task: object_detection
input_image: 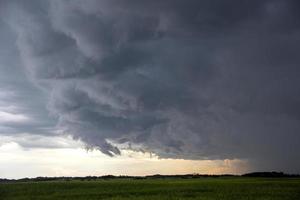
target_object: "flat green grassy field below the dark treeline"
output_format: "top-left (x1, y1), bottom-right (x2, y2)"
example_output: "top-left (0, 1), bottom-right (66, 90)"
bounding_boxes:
top-left (0, 177), bottom-right (300, 200)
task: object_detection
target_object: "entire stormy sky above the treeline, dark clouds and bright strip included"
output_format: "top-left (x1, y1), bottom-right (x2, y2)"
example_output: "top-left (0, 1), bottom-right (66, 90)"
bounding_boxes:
top-left (0, 0), bottom-right (300, 178)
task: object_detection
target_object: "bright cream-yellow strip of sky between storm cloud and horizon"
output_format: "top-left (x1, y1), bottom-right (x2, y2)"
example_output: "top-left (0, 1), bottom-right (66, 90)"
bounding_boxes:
top-left (0, 134), bottom-right (249, 178)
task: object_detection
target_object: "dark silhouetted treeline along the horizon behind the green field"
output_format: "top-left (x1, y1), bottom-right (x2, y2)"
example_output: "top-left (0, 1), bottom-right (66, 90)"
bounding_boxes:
top-left (0, 172), bottom-right (300, 183)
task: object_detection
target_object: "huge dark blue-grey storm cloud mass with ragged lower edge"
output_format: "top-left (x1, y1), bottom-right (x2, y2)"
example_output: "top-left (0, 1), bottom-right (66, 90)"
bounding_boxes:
top-left (1, 0), bottom-right (300, 172)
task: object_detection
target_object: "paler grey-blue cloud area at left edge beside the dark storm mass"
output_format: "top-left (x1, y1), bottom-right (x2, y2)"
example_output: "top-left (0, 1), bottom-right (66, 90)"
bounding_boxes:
top-left (0, 13), bottom-right (55, 135)
